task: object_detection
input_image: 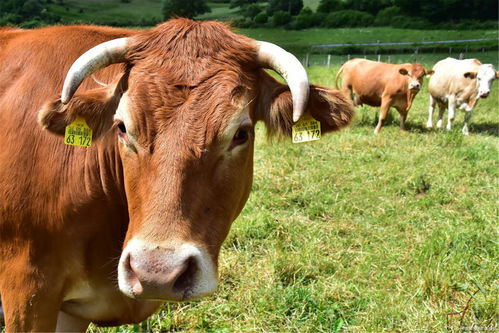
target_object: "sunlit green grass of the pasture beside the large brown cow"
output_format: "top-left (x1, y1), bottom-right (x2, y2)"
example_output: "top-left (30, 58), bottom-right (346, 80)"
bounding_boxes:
top-left (91, 67), bottom-right (499, 332)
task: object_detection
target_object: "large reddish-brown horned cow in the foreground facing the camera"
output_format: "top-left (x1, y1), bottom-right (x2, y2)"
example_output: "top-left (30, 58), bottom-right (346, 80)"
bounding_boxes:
top-left (0, 19), bottom-right (354, 332)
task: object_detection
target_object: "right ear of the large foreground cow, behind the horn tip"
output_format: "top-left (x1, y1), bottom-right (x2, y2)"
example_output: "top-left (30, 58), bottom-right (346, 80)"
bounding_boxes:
top-left (256, 75), bottom-right (355, 138)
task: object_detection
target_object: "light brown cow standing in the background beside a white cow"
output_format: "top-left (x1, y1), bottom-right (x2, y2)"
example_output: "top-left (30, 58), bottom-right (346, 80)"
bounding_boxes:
top-left (336, 59), bottom-right (432, 133)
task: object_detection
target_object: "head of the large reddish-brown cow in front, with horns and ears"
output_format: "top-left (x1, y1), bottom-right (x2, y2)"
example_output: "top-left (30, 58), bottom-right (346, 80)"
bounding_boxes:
top-left (39, 19), bottom-right (354, 301)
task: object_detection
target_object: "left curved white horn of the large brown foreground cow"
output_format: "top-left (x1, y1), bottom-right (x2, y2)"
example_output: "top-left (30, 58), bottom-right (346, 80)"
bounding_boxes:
top-left (61, 37), bottom-right (128, 104)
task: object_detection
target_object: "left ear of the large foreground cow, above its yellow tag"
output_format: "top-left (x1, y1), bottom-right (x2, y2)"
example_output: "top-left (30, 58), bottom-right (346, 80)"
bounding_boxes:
top-left (38, 78), bottom-right (123, 139)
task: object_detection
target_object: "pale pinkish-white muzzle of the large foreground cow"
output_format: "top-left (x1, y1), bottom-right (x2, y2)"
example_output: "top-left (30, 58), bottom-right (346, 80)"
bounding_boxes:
top-left (118, 239), bottom-right (218, 302)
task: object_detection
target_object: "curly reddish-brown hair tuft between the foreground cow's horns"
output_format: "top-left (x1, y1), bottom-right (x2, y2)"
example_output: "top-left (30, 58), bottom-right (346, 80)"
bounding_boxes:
top-left (128, 18), bottom-right (257, 76)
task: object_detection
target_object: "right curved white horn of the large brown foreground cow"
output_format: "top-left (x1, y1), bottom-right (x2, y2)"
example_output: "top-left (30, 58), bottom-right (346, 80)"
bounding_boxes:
top-left (257, 41), bottom-right (310, 122)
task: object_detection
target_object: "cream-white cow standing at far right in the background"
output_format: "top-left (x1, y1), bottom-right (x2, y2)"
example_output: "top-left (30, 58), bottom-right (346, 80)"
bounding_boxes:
top-left (426, 58), bottom-right (499, 135)
